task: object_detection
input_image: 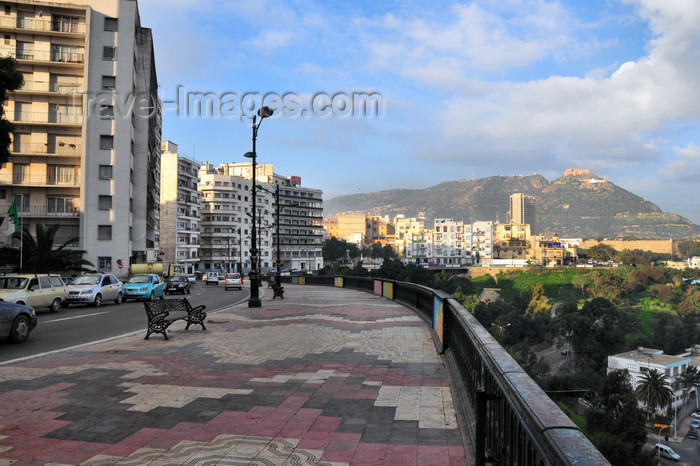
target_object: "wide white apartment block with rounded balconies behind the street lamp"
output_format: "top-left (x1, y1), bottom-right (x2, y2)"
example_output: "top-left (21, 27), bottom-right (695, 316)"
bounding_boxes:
top-left (199, 163), bottom-right (323, 273)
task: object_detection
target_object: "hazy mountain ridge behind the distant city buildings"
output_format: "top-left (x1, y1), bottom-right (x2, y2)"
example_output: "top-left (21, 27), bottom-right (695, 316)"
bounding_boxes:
top-left (323, 168), bottom-right (700, 239)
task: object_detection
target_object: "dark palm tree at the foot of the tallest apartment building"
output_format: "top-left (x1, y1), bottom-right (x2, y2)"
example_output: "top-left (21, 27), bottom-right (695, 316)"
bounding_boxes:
top-left (0, 223), bottom-right (93, 273)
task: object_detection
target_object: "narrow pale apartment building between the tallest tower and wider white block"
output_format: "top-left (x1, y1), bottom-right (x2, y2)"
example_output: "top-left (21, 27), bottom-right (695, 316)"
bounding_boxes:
top-left (160, 141), bottom-right (200, 273)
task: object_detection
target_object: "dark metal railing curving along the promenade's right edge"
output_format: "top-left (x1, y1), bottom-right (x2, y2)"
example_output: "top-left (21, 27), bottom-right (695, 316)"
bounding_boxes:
top-left (292, 276), bottom-right (610, 466)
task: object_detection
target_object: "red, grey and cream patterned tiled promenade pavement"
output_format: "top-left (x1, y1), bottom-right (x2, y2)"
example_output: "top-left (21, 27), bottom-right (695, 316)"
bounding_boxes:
top-left (0, 285), bottom-right (466, 465)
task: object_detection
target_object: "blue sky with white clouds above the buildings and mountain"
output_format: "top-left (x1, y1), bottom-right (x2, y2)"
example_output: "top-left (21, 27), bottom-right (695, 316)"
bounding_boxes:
top-left (139, 0), bottom-right (700, 223)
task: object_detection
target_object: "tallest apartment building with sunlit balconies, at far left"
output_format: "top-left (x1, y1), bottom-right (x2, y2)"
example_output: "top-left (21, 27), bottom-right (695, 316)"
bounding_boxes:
top-left (0, 0), bottom-right (162, 275)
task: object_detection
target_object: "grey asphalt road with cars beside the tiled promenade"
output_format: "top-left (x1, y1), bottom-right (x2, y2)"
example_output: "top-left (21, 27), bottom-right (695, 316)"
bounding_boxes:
top-left (0, 281), bottom-right (248, 364)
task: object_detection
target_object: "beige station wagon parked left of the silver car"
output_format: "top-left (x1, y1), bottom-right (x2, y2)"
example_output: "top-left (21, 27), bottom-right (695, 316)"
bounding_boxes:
top-left (0, 274), bottom-right (68, 312)
